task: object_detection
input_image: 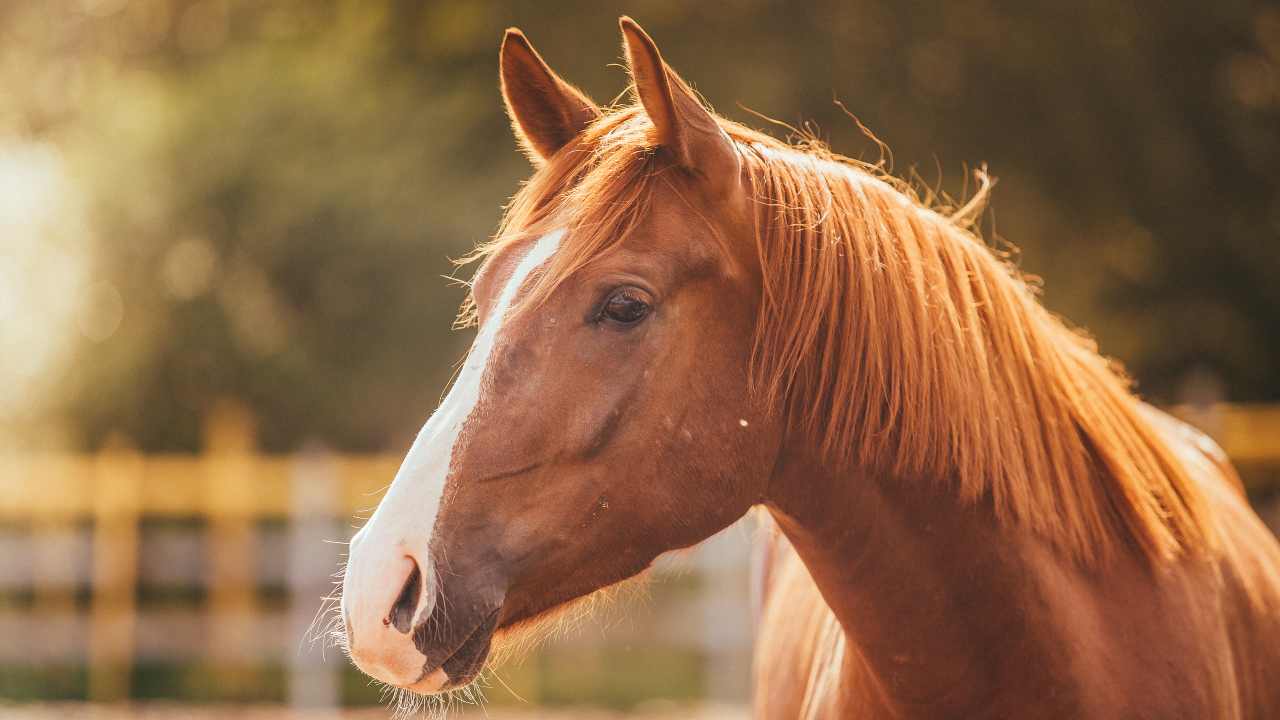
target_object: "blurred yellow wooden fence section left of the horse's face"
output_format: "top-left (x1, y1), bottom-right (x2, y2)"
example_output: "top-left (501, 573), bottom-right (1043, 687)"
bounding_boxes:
top-left (0, 405), bottom-right (399, 701)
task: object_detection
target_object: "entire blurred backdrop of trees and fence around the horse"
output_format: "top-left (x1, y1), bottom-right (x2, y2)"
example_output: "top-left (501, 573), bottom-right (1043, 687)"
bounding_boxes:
top-left (0, 0), bottom-right (1280, 717)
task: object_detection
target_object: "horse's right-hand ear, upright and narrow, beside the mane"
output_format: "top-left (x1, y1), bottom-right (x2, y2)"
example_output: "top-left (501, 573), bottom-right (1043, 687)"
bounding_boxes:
top-left (618, 15), bottom-right (737, 178)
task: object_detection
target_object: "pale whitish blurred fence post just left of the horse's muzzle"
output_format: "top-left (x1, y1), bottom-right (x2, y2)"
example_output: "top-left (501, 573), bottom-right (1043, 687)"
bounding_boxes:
top-left (288, 445), bottom-right (347, 716)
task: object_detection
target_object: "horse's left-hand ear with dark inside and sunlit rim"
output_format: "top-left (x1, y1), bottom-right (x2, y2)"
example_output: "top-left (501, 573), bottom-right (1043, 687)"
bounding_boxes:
top-left (498, 28), bottom-right (600, 165)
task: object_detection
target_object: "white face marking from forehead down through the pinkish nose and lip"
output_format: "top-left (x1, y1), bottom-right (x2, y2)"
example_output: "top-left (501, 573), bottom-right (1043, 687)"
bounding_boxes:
top-left (342, 229), bottom-right (564, 692)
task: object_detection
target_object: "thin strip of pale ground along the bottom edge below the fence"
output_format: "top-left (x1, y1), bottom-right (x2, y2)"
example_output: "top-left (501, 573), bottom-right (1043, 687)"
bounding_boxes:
top-left (0, 703), bottom-right (748, 720)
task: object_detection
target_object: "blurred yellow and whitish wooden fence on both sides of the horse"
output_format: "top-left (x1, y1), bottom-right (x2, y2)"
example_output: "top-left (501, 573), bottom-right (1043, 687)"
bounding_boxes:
top-left (0, 405), bottom-right (1280, 705)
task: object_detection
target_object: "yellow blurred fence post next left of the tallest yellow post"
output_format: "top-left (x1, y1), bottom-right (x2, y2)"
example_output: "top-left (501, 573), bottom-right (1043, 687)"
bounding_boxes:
top-left (88, 430), bottom-right (143, 702)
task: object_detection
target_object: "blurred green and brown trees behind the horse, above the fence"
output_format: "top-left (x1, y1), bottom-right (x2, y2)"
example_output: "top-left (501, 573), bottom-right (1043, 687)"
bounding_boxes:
top-left (0, 0), bottom-right (1280, 450)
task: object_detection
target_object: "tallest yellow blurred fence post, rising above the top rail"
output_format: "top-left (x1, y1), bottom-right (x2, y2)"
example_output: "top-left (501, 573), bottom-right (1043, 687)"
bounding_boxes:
top-left (205, 400), bottom-right (257, 681)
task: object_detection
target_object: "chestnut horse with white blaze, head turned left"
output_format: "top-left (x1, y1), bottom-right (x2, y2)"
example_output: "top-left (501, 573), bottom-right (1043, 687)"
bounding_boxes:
top-left (340, 18), bottom-right (1280, 719)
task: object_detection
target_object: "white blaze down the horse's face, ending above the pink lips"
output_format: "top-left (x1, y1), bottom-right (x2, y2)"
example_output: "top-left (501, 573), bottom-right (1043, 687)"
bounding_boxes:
top-left (342, 229), bottom-right (564, 635)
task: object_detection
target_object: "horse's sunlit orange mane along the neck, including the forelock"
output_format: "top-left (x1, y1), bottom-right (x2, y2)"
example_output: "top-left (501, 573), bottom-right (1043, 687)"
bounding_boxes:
top-left (461, 106), bottom-right (1210, 564)
